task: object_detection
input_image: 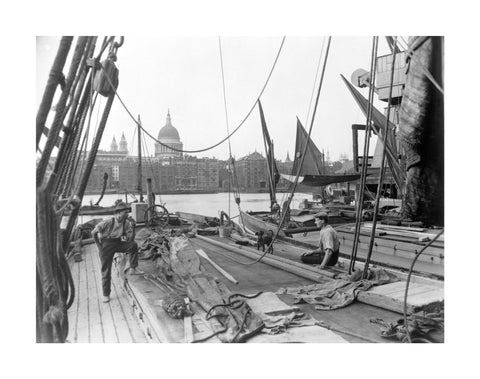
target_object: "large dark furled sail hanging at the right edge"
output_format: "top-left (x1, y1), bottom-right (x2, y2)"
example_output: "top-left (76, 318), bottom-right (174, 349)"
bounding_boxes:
top-left (398, 37), bottom-right (445, 225)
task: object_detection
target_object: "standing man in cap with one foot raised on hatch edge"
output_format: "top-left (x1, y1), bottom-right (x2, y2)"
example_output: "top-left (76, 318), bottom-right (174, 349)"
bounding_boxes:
top-left (92, 202), bottom-right (143, 303)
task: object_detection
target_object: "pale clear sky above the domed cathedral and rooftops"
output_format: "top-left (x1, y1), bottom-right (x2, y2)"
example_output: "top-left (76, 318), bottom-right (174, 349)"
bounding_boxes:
top-left (36, 35), bottom-right (398, 165)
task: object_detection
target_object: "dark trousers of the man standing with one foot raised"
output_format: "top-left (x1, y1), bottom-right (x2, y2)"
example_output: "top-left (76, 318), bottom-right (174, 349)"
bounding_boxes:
top-left (100, 238), bottom-right (138, 296)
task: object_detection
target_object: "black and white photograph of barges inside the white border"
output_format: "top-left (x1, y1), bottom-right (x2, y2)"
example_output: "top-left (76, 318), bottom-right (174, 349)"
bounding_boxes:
top-left (36, 36), bottom-right (445, 343)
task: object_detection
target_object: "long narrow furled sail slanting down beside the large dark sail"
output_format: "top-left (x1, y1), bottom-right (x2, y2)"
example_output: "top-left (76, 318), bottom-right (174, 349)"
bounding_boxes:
top-left (340, 75), bottom-right (405, 190)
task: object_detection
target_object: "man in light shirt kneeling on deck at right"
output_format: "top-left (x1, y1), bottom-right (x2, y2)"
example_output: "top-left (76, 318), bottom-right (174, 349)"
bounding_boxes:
top-left (301, 212), bottom-right (340, 268)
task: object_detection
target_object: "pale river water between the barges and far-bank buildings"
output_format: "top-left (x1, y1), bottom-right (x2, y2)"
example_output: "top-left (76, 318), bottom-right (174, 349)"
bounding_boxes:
top-left (79, 192), bottom-right (312, 223)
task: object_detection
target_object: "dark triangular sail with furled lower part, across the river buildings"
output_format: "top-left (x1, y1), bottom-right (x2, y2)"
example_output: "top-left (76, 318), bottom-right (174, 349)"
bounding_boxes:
top-left (281, 118), bottom-right (360, 187)
